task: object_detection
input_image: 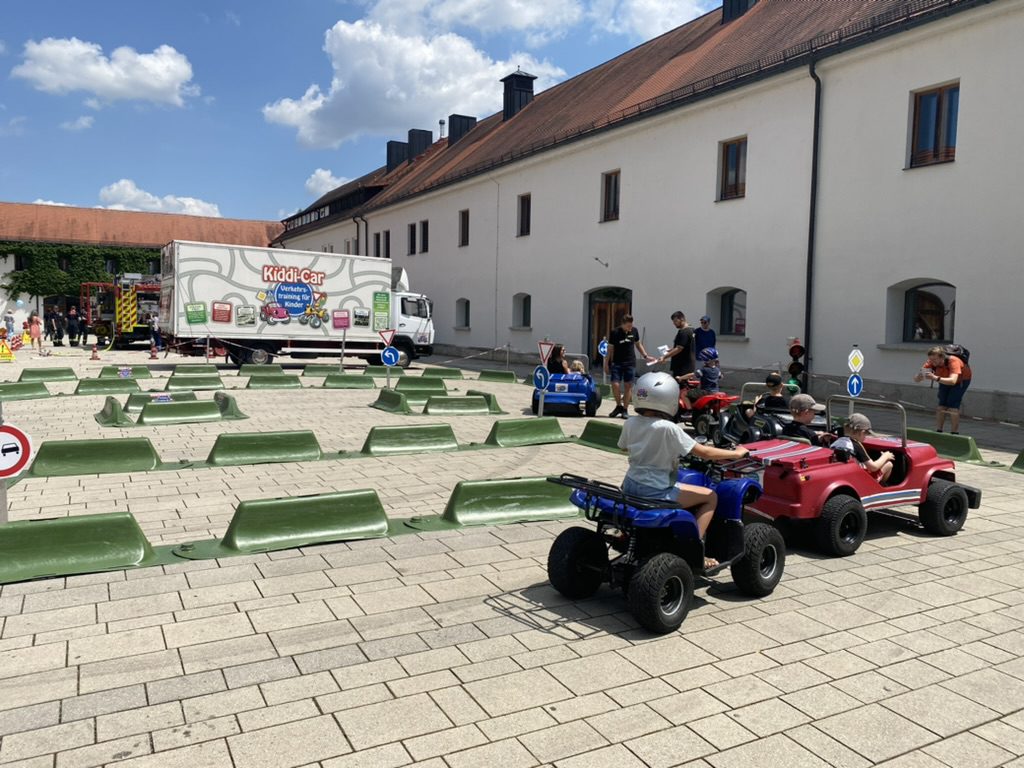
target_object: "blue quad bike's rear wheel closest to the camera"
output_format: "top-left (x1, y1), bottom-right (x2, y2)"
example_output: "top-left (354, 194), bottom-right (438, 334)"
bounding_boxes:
top-left (627, 552), bottom-right (693, 634)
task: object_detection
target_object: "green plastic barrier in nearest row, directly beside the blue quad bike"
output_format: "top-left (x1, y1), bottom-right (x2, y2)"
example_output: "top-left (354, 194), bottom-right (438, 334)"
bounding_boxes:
top-left (406, 477), bottom-right (580, 530)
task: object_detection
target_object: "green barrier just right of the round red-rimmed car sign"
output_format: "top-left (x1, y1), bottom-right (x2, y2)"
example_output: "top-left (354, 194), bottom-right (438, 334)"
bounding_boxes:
top-left (28, 438), bottom-right (160, 477)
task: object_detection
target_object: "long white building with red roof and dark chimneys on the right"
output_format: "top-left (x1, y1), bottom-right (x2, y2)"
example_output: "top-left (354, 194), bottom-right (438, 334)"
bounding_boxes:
top-left (279, 0), bottom-right (1024, 421)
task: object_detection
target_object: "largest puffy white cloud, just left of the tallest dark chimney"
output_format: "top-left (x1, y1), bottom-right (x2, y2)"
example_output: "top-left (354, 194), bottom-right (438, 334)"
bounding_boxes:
top-left (263, 20), bottom-right (565, 147)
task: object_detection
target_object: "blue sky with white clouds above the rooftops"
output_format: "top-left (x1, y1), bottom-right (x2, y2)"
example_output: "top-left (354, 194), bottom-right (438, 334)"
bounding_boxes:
top-left (0, 0), bottom-right (721, 219)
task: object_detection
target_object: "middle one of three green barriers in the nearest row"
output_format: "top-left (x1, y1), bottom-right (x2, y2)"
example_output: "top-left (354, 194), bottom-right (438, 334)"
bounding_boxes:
top-left (174, 483), bottom-right (387, 560)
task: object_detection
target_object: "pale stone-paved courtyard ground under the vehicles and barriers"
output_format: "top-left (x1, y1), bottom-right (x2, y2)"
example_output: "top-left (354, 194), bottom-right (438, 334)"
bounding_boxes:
top-left (0, 352), bottom-right (1024, 768)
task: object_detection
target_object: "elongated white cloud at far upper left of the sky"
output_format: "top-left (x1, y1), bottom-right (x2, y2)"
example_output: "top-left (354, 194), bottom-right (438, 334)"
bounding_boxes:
top-left (11, 37), bottom-right (199, 106)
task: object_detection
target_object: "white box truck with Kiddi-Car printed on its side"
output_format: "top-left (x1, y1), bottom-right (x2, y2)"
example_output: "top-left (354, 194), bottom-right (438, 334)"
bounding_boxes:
top-left (159, 241), bottom-right (434, 366)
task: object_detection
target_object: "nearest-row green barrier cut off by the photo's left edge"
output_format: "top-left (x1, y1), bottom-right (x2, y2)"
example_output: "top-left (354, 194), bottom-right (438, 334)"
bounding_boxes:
top-left (0, 512), bottom-right (162, 584)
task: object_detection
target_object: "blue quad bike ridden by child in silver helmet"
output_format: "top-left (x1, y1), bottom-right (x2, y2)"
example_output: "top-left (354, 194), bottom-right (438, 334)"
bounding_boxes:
top-left (548, 459), bottom-right (785, 634)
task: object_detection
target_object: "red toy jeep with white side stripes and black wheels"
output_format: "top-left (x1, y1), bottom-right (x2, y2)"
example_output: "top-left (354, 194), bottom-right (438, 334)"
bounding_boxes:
top-left (746, 396), bottom-right (981, 556)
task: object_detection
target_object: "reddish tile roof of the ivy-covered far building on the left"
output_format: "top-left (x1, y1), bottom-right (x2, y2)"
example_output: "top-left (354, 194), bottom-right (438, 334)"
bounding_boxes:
top-left (0, 203), bottom-right (284, 248)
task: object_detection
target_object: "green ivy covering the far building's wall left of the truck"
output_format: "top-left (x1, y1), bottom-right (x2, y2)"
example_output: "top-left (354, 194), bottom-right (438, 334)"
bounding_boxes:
top-left (0, 243), bottom-right (160, 298)
